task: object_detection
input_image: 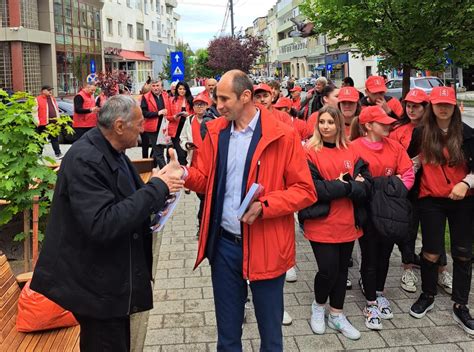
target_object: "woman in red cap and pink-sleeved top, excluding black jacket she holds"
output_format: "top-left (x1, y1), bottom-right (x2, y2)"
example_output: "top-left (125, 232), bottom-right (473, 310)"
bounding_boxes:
top-left (351, 106), bottom-right (415, 330)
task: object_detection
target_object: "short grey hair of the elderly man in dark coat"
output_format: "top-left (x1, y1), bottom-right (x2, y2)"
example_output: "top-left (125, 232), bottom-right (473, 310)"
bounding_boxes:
top-left (97, 95), bottom-right (138, 129)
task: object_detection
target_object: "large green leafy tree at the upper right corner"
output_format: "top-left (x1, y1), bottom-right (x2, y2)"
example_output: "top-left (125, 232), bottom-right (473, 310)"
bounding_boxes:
top-left (301, 0), bottom-right (474, 97)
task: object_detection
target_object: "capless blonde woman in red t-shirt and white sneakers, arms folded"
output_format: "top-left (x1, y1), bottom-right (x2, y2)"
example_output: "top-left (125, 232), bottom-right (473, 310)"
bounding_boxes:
top-left (304, 106), bottom-right (364, 340)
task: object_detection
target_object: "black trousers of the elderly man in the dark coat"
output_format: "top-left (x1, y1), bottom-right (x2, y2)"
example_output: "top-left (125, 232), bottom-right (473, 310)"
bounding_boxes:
top-left (74, 314), bottom-right (130, 352)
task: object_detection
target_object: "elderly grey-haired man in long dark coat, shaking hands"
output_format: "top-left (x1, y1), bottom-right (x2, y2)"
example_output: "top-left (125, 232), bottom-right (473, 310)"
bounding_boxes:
top-left (31, 95), bottom-right (183, 351)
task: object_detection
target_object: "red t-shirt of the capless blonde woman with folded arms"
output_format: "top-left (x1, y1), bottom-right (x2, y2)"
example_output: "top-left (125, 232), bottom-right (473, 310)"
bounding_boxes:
top-left (304, 145), bottom-right (362, 243)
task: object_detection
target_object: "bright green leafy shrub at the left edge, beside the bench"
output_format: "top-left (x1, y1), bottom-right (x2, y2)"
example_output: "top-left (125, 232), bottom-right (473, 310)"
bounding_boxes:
top-left (0, 90), bottom-right (73, 225)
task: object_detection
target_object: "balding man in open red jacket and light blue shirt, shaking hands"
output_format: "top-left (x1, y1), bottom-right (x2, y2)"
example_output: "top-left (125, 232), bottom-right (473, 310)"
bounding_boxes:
top-left (170, 70), bottom-right (316, 351)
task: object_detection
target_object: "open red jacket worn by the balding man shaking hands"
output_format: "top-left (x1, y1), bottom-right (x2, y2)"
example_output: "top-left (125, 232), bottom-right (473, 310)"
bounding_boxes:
top-left (185, 106), bottom-right (316, 281)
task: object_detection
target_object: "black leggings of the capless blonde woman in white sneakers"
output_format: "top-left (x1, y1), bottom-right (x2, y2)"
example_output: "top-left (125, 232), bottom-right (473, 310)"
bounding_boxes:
top-left (310, 241), bottom-right (354, 309)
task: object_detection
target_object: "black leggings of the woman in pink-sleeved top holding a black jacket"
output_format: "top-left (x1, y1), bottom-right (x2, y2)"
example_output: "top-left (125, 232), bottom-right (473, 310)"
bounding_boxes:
top-left (359, 221), bottom-right (394, 302)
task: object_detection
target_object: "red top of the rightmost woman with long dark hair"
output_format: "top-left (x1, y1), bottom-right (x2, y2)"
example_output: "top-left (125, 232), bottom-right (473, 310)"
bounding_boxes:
top-left (418, 148), bottom-right (469, 198)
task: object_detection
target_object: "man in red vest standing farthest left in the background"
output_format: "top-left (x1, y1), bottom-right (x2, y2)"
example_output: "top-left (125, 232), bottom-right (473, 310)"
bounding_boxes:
top-left (33, 85), bottom-right (63, 159)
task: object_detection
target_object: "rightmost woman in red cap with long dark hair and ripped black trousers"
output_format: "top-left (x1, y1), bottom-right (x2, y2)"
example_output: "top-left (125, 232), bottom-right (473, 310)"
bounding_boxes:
top-left (408, 87), bottom-right (474, 335)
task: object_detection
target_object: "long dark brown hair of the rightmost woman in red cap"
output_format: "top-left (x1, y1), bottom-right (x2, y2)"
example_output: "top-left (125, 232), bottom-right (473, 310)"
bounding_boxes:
top-left (421, 104), bottom-right (465, 166)
